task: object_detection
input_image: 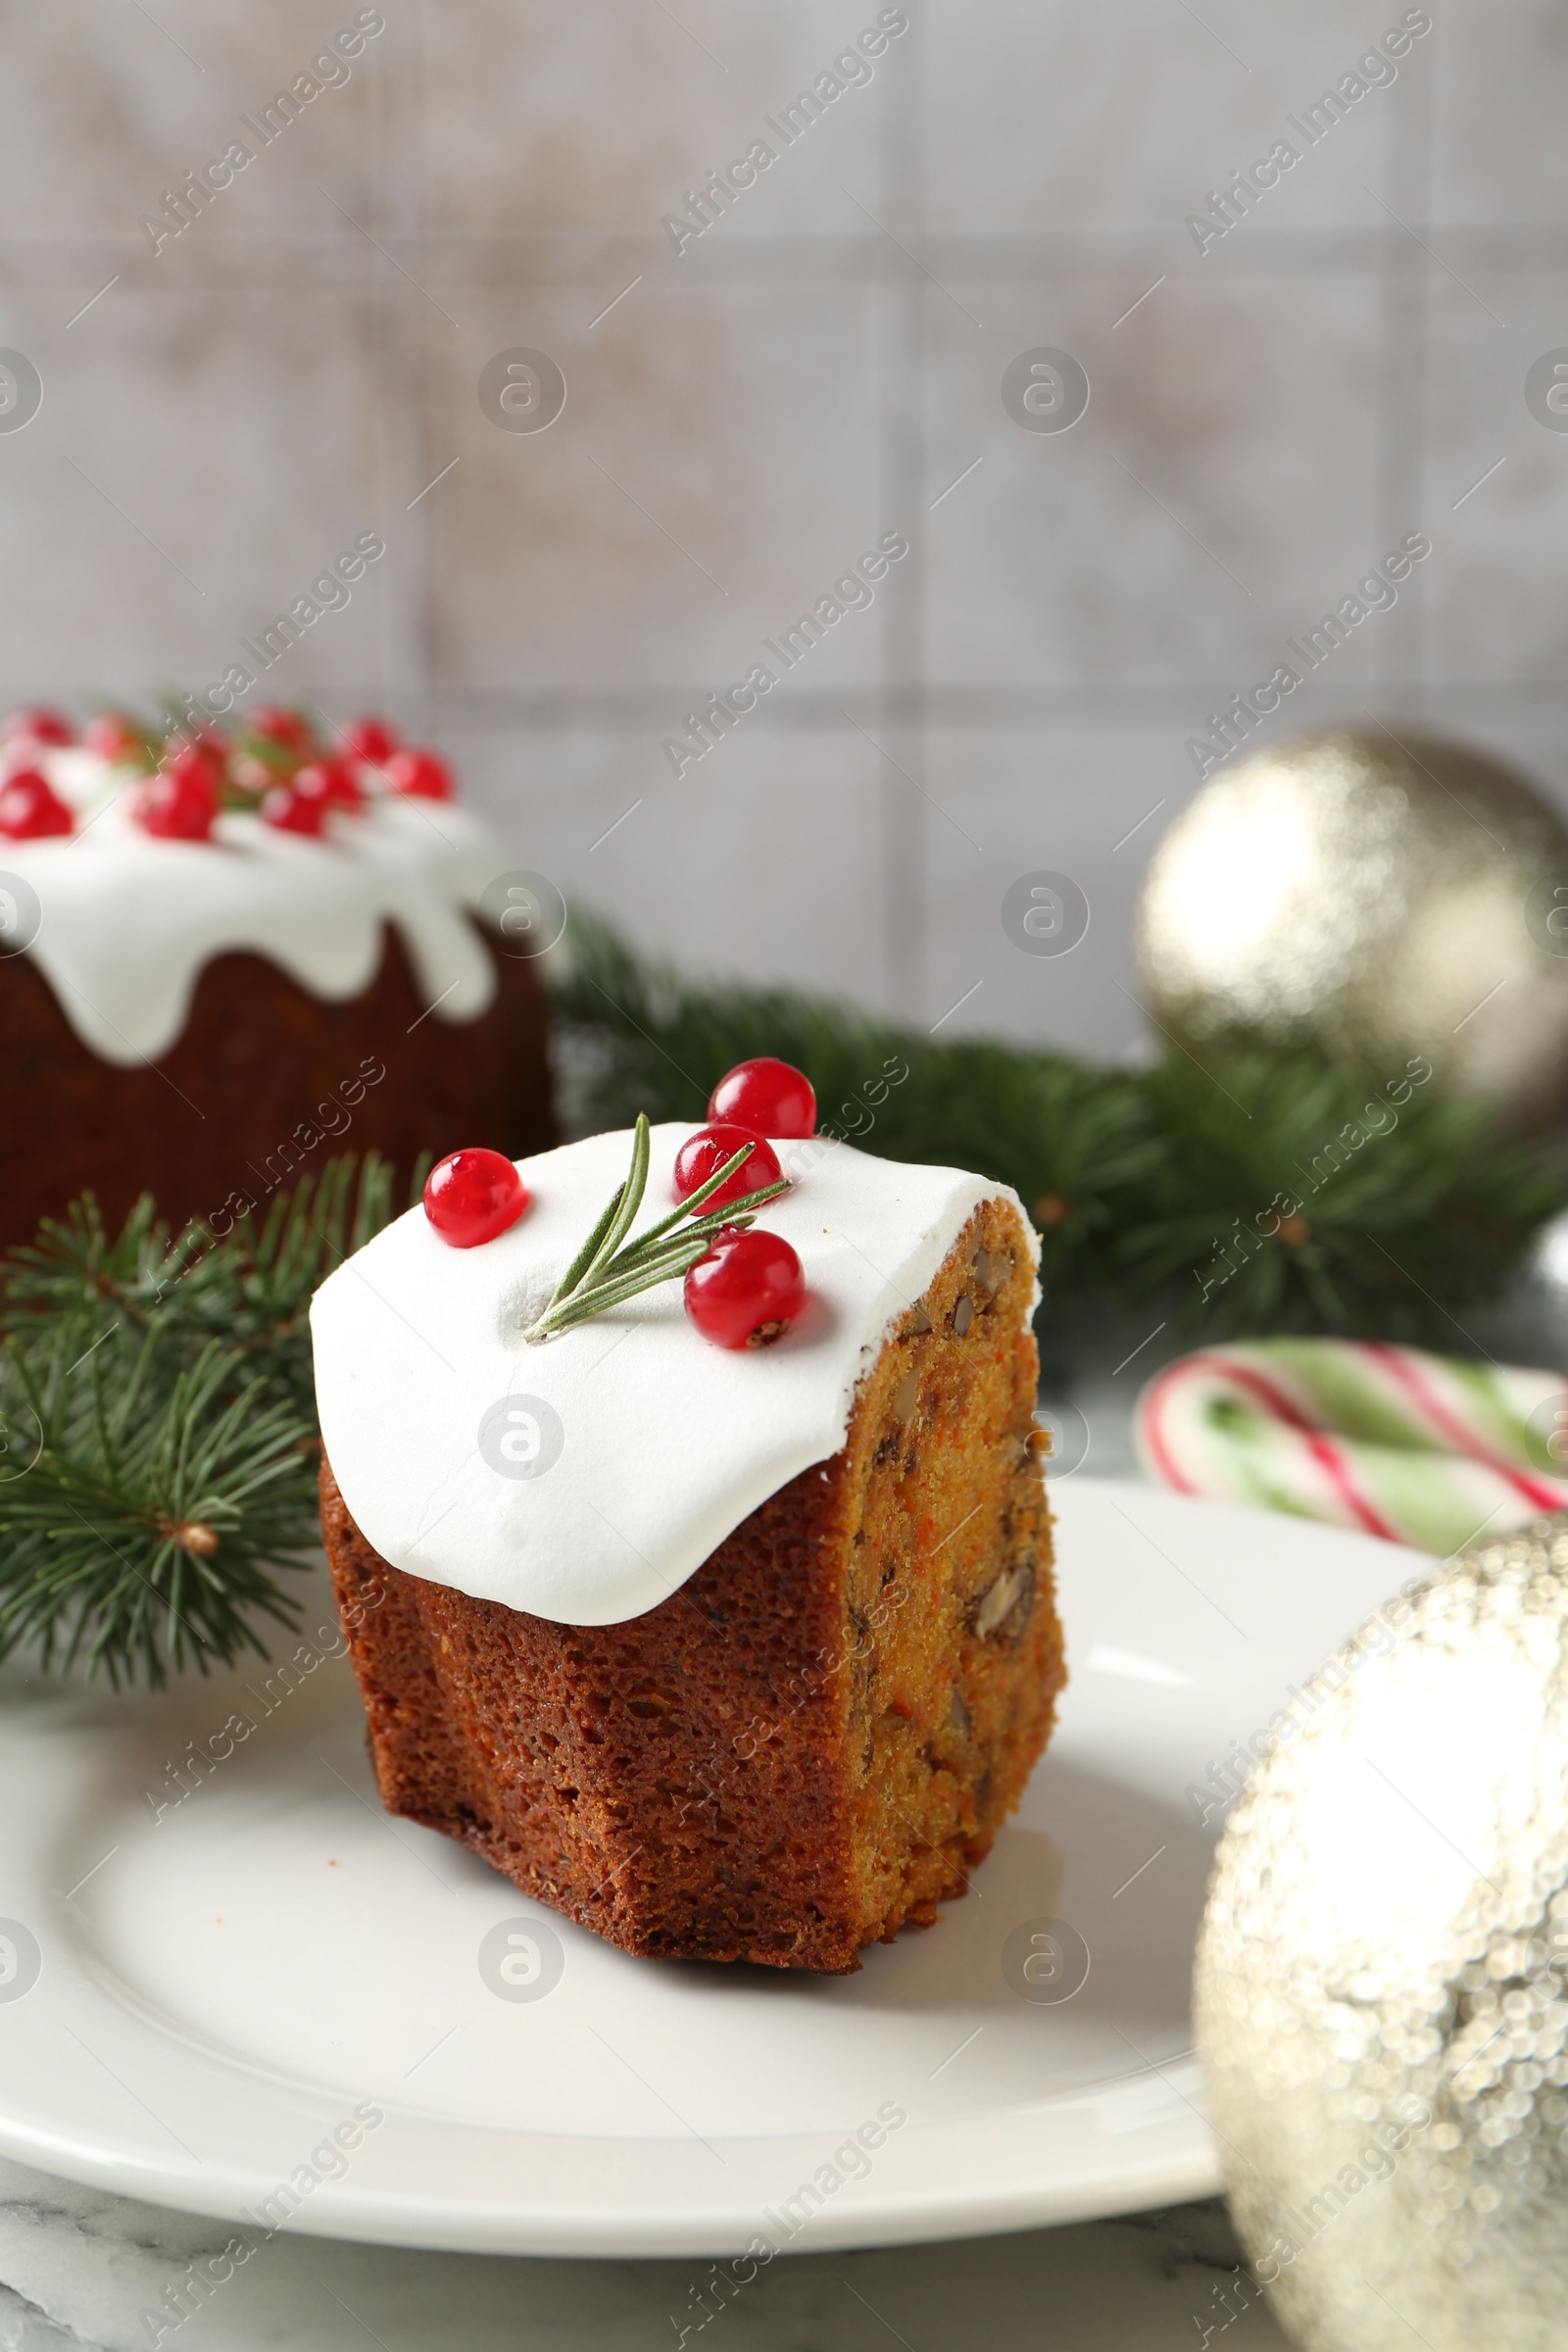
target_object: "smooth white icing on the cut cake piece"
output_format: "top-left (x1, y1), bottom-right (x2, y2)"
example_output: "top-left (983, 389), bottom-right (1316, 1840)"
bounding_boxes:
top-left (311, 1124), bottom-right (1022, 1625)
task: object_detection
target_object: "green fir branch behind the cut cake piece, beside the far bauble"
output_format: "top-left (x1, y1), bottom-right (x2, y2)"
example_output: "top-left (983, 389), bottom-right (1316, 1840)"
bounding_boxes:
top-left (555, 915), bottom-right (1568, 1350)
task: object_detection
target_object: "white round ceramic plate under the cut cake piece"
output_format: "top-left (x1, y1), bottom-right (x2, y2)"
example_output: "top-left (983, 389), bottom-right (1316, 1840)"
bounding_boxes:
top-left (0, 1477), bottom-right (1425, 2256)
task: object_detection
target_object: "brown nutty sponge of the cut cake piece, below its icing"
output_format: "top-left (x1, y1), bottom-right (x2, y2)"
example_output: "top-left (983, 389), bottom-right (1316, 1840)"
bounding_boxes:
top-left (322, 1200), bottom-right (1065, 1971)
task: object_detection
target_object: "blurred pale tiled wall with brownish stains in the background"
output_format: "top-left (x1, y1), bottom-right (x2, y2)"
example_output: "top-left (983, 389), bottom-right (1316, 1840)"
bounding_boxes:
top-left (0, 0), bottom-right (1568, 1054)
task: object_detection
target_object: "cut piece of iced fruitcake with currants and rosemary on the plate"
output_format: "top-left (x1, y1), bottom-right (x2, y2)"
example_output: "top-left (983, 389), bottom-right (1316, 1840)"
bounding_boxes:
top-left (313, 1063), bottom-right (1065, 1971)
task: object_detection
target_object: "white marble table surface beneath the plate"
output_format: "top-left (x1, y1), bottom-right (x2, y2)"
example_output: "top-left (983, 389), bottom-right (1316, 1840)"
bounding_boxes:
top-left (0, 1329), bottom-right (1286, 2352)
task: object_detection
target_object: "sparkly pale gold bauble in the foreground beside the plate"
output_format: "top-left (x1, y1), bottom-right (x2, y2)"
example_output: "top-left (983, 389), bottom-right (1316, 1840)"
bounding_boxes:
top-left (1195, 1512), bottom-right (1568, 2352)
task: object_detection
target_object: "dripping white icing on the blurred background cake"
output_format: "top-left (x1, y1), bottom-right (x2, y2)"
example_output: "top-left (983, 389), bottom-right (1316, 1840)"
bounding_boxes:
top-left (0, 751), bottom-right (506, 1068)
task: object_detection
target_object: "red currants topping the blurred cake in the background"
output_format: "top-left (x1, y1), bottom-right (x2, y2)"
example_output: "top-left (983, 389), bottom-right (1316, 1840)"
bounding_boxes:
top-left (0, 704), bottom-right (452, 842)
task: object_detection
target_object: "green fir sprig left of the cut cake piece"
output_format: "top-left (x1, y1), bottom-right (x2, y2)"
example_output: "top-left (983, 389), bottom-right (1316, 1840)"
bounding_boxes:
top-left (0, 1154), bottom-right (423, 1687)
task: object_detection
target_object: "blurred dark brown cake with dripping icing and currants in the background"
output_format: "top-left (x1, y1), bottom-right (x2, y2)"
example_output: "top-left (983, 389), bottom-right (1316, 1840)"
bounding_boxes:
top-left (0, 710), bottom-right (553, 1247)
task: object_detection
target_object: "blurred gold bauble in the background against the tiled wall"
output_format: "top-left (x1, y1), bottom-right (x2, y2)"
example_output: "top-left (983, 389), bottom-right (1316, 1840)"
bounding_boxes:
top-left (1138, 729), bottom-right (1568, 1124)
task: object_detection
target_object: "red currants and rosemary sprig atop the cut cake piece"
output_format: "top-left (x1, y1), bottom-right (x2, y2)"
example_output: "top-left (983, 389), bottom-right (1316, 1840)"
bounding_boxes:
top-left (425, 1058), bottom-right (815, 1348)
